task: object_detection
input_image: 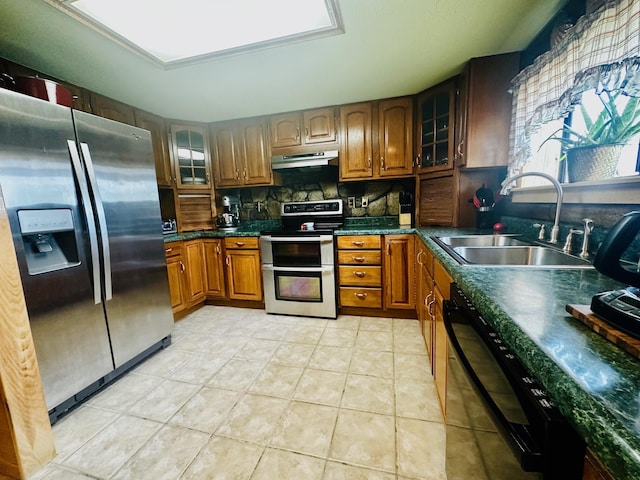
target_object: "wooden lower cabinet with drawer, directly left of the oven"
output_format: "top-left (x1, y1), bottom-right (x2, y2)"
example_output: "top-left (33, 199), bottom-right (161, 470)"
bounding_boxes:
top-left (224, 237), bottom-right (263, 302)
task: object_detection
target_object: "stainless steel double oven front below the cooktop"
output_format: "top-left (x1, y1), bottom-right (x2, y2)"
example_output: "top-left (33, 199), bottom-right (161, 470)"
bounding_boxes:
top-left (260, 233), bottom-right (337, 318)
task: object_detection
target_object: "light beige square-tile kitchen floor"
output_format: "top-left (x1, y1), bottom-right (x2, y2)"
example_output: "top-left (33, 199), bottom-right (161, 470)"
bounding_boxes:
top-left (33, 306), bottom-right (446, 480)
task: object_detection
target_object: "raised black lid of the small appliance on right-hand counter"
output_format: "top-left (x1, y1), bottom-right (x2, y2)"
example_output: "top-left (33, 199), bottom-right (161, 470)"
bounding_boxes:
top-left (593, 211), bottom-right (640, 287)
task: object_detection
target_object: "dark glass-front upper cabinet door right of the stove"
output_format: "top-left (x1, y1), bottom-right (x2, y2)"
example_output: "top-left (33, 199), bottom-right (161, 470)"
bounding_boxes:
top-left (417, 81), bottom-right (456, 173)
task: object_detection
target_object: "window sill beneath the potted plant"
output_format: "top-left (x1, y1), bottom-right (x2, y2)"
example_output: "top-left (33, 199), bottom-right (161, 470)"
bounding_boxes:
top-left (511, 175), bottom-right (640, 205)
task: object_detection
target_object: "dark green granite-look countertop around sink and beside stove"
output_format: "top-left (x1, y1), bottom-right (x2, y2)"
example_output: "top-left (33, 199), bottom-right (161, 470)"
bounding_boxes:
top-left (165, 221), bottom-right (640, 479)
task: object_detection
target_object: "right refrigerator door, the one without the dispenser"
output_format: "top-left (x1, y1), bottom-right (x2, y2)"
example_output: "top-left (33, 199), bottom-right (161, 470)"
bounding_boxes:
top-left (73, 111), bottom-right (173, 368)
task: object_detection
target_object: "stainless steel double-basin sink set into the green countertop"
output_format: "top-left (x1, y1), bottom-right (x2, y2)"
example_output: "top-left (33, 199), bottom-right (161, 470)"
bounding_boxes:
top-left (431, 235), bottom-right (593, 268)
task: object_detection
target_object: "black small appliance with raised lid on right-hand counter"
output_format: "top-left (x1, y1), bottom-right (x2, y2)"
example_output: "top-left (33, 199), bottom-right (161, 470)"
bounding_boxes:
top-left (591, 211), bottom-right (640, 339)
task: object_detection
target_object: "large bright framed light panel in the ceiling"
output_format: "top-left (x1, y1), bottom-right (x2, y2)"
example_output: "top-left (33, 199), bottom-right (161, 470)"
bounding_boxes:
top-left (44, 0), bottom-right (344, 67)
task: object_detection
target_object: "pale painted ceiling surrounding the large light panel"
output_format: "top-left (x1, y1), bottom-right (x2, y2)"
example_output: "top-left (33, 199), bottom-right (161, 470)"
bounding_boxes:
top-left (0, 0), bottom-right (565, 122)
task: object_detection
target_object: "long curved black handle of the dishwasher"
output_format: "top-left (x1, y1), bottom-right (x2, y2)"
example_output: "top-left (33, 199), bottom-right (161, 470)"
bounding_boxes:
top-left (442, 300), bottom-right (542, 471)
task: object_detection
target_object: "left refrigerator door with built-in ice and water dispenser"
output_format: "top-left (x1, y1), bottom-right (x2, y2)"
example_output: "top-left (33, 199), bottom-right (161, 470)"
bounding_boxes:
top-left (0, 90), bottom-right (114, 409)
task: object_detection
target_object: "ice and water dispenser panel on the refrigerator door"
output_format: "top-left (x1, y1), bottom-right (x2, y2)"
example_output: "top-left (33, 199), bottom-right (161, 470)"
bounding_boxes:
top-left (18, 208), bottom-right (80, 275)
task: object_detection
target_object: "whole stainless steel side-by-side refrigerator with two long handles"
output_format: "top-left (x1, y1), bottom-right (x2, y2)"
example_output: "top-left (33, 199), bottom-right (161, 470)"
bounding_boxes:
top-left (0, 90), bottom-right (173, 422)
